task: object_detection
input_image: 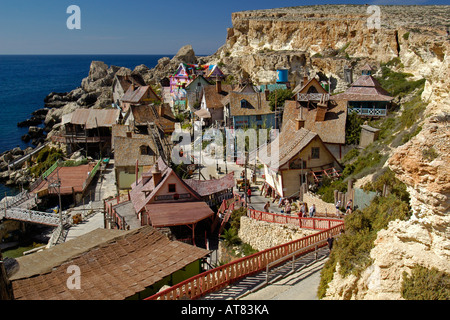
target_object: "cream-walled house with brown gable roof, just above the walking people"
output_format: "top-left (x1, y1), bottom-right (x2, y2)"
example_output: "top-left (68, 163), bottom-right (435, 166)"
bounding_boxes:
top-left (258, 119), bottom-right (342, 197)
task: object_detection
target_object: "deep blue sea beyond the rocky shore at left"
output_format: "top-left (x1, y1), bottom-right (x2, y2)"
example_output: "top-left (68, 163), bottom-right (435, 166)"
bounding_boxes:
top-left (0, 54), bottom-right (173, 199)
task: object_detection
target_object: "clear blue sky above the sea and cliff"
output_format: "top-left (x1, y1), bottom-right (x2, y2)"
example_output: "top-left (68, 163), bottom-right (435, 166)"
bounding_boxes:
top-left (0, 0), bottom-right (448, 55)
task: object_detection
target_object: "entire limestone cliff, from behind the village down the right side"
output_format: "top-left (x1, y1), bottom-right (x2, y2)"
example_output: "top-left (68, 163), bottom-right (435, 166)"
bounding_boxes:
top-left (201, 5), bottom-right (450, 299)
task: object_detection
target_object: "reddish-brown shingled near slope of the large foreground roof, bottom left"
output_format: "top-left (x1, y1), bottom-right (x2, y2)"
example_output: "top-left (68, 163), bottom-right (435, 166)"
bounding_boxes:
top-left (12, 226), bottom-right (209, 300)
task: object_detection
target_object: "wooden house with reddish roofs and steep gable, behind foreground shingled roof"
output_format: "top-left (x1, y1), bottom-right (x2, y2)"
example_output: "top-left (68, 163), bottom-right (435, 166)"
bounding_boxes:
top-left (105, 158), bottom-right (234, 245)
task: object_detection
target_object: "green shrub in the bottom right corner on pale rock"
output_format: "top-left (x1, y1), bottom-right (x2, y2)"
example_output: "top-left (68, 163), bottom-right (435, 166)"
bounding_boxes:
top-left (401, 265), bottom-right (450, 300)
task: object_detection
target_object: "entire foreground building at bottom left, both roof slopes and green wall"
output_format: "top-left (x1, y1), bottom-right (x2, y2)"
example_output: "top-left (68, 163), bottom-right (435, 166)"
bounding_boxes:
top-left (10, 226), bottom-right (209, 300)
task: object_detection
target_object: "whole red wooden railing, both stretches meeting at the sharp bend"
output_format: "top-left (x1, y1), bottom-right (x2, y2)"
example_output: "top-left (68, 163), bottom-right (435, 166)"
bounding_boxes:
top-left (145, 199), bottom-right (344, 300)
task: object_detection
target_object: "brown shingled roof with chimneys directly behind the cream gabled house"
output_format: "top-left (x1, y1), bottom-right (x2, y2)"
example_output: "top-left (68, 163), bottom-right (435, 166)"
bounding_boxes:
top-left (281, 100), bottom-right (347, 144)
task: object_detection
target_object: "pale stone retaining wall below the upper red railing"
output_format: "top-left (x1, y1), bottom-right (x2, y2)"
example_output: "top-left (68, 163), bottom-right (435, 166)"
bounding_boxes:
top-left (238, 216), bottom-right (318, 251)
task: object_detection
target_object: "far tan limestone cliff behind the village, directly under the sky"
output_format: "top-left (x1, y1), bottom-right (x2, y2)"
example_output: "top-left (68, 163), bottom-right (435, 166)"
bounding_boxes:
top-left (207, 5), bottom-right (450, 91)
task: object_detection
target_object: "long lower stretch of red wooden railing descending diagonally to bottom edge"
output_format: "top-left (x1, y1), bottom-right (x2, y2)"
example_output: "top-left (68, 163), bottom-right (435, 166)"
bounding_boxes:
top-left (145, 222), bottom-right (344, 300)
